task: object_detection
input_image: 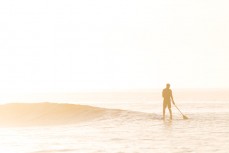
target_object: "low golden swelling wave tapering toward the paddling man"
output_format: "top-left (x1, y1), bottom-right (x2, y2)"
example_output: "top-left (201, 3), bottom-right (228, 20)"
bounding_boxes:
top-left (0, 103), bottom-right (159, 127)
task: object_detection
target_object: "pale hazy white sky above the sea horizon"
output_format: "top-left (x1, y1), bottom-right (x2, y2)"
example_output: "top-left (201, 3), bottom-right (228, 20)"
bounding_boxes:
top-left (0, 0), bottom-right (229, 93)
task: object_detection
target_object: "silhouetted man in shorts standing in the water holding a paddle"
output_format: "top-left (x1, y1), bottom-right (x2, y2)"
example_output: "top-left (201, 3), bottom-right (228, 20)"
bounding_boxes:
top-left (162, 83), bottom-right (175, 120)
